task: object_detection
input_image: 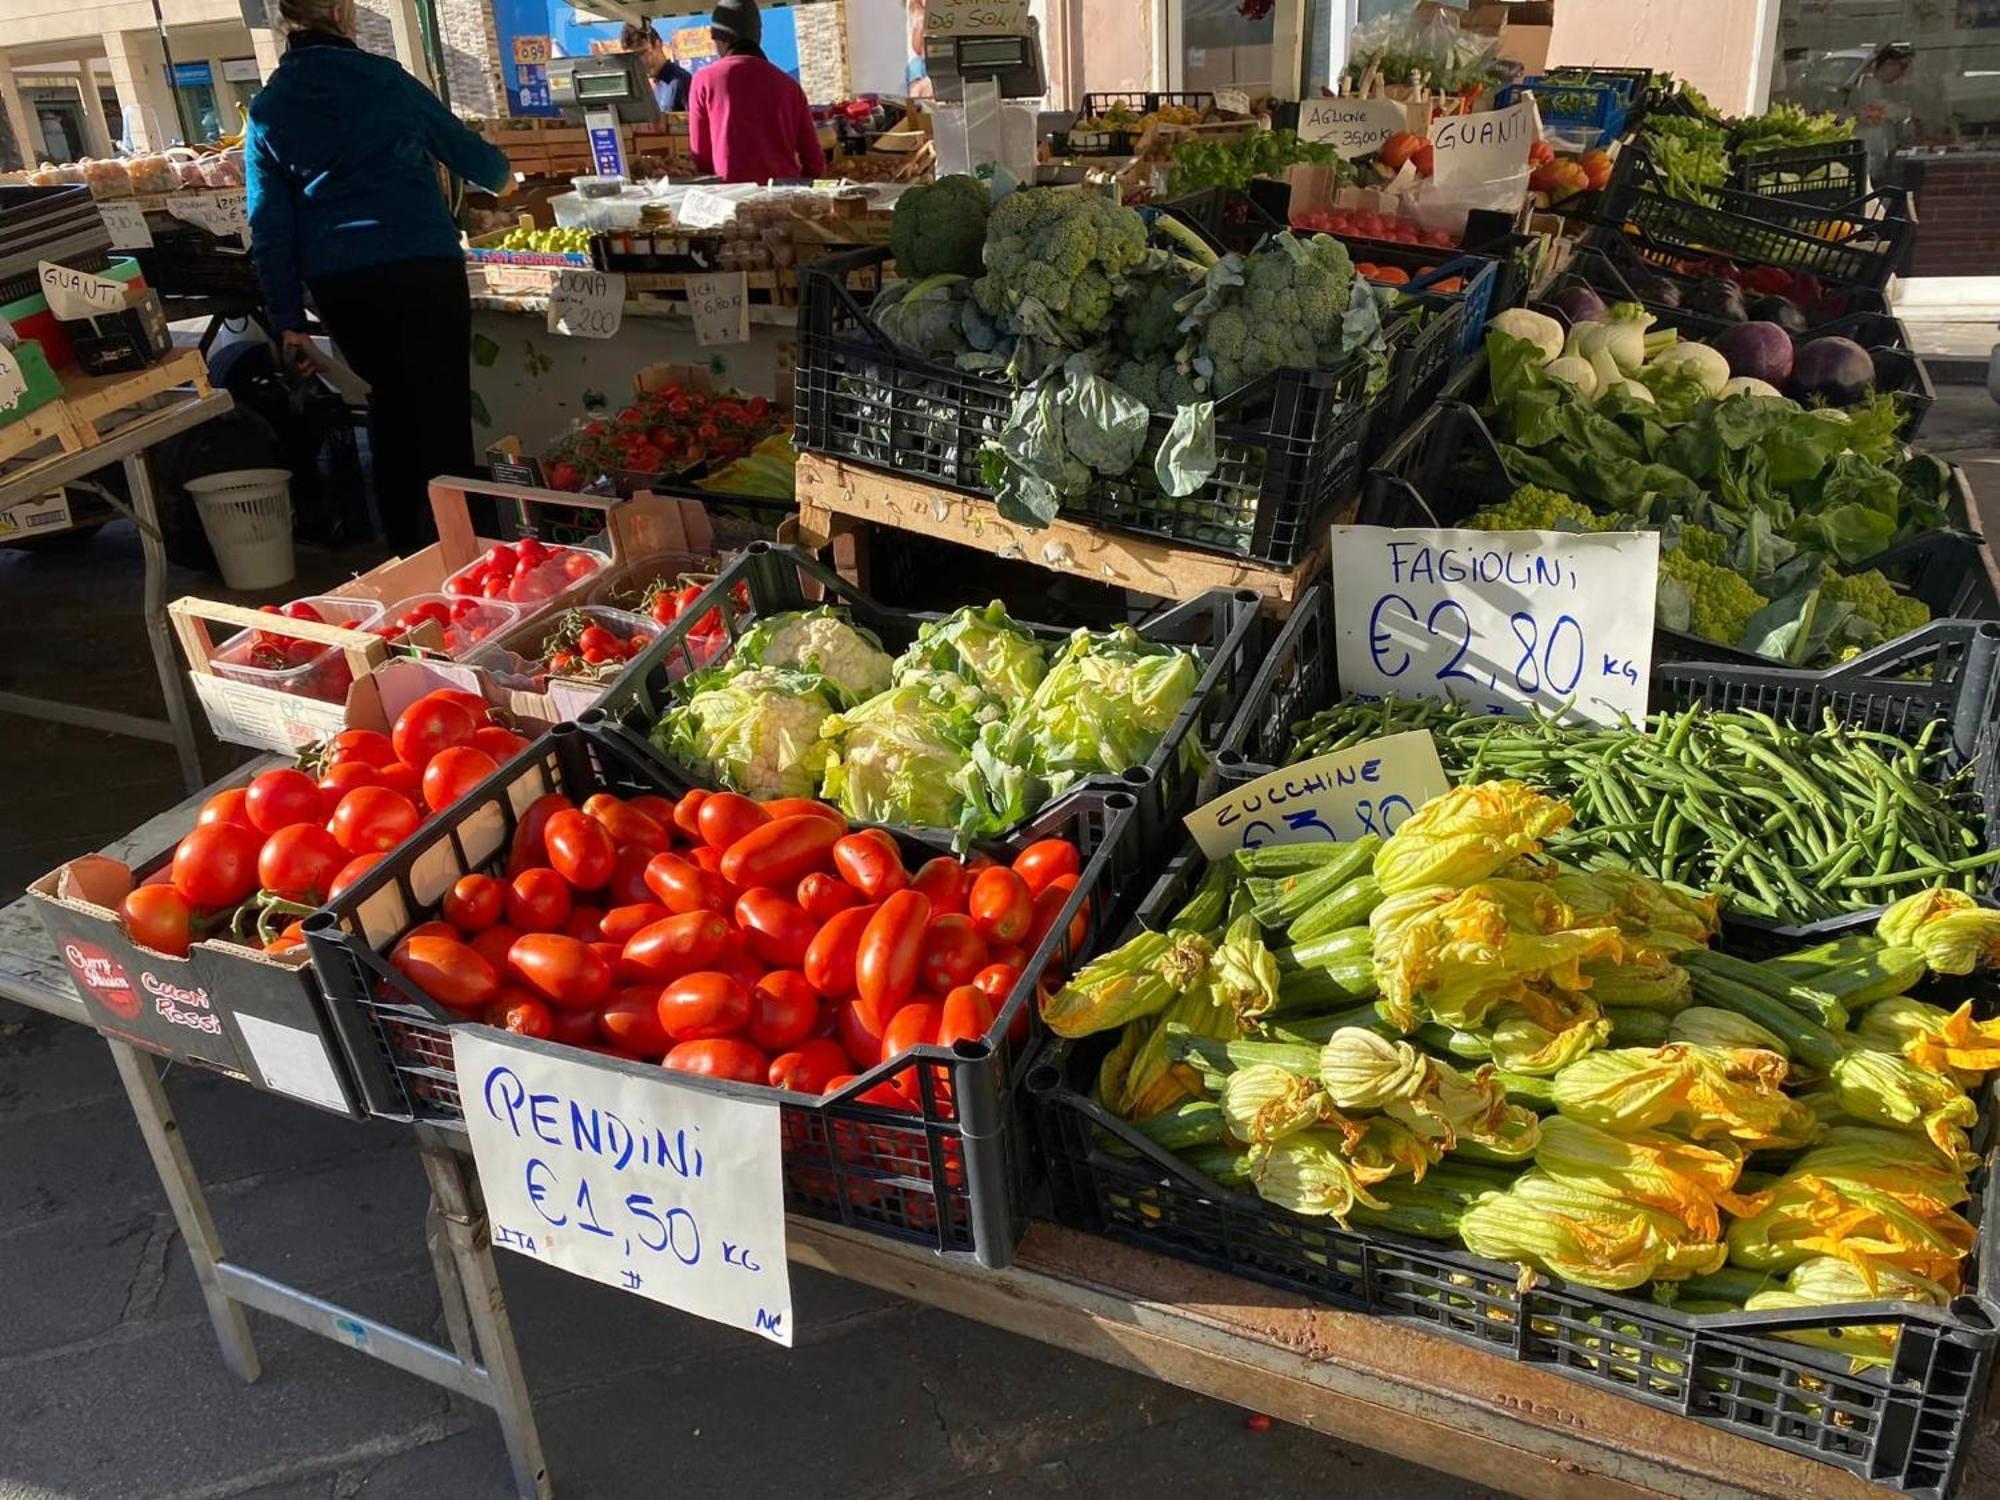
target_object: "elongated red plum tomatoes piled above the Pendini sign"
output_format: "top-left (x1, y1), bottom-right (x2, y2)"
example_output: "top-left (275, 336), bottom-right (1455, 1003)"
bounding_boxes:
top-left (390, 790), bottom-right (1084, 1108)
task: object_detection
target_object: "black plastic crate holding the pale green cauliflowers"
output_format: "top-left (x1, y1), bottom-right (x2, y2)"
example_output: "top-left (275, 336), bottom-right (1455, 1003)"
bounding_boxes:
top-left (580, 542), bottom-right (1262, 856)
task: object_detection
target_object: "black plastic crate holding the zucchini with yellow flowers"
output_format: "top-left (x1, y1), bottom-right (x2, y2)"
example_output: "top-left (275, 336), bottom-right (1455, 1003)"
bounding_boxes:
top-left (1028, 916), bottom-right (2000, 1500)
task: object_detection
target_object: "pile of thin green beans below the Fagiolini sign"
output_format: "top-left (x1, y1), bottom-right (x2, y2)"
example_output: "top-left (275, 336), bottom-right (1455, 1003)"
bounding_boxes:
top-left (1292, 698), bottom-right (2000, 922)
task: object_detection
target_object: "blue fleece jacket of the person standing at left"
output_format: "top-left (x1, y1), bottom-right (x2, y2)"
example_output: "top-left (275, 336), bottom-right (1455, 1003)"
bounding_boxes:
top-left (244, 34), bottom-right (510, 332)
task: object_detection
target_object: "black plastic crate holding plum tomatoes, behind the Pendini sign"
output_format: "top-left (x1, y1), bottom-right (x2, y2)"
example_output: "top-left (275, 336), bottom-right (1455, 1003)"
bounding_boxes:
top-left (304, 724), bottom-right (1142, 1268)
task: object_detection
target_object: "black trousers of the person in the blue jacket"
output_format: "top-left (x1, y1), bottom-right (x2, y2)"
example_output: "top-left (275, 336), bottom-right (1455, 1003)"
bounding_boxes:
top-left (310, 256), bottom-right (474, 552)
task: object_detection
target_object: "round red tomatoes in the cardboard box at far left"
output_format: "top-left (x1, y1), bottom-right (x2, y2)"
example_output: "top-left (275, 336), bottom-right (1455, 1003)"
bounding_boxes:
top-left (120, 688), bottom-right (528, 958)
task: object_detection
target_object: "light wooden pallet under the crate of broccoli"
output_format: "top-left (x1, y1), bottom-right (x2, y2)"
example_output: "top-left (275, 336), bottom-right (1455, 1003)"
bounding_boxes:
top-left (798, 454), bottom-right (1338, 618)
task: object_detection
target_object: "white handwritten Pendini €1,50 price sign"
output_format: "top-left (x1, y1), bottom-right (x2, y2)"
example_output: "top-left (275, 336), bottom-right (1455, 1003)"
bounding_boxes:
top-left (452, 1028), bottom-right (792, 1346)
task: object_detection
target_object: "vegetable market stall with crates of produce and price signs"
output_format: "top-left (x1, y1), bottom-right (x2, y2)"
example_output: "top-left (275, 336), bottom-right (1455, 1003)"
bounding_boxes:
top-left (11, 32), bottom-right (2000, 1500)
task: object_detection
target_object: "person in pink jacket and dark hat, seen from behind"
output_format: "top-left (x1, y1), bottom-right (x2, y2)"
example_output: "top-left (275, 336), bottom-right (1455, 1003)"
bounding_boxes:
top-left (688, 0), bottom-right (826, 182)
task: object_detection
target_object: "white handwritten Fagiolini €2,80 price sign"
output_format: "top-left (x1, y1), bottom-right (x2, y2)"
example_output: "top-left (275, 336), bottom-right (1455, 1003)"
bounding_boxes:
top-left (1332, 526), bottom-right (1660, 724)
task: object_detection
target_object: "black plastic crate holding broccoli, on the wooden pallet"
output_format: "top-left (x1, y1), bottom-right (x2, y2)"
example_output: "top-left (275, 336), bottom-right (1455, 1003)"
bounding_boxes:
top-left (794, 248), bottom-right (1404, 568)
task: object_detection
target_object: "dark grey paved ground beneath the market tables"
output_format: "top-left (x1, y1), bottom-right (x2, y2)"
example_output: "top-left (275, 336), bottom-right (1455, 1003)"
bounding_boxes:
top-left (0, 502), bottom-right (1504, 1500)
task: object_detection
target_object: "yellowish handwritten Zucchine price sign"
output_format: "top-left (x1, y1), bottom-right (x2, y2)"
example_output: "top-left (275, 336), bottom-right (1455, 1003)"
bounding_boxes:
top-left (1184, 728), bottom-right (1450, 860)
